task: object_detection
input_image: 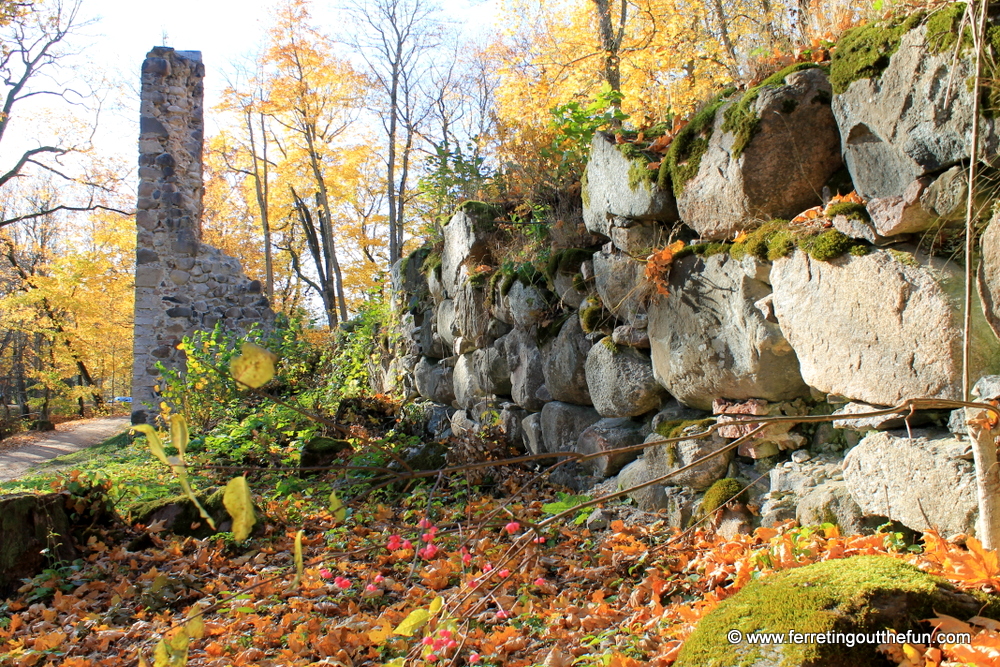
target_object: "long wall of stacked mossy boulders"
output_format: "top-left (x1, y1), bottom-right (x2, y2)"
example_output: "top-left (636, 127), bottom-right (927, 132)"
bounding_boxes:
top-left (390, 13), bottom-right (1000, 534)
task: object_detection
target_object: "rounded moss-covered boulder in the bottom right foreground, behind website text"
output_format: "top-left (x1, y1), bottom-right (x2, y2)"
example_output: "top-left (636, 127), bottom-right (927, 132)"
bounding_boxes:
top-left (674, 556), bottom-right (996, 667)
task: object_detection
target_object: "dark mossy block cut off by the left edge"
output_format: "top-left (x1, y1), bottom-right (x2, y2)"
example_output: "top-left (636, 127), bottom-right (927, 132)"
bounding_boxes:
top-left (0, 493), bottom-right (76, 597)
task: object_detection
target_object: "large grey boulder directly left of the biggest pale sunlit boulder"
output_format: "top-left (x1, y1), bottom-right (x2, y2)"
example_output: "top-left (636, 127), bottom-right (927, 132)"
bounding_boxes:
top-left (649, 254), bottom-right (808, 410)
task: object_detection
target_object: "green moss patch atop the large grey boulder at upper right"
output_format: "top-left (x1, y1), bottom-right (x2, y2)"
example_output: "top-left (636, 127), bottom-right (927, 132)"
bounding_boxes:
top-left (830, 12), bottom-right (925, 94)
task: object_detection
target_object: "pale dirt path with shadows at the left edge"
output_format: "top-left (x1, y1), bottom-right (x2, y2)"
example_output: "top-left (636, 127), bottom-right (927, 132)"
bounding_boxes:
top-left (0, 417), bottom-right (129, 482)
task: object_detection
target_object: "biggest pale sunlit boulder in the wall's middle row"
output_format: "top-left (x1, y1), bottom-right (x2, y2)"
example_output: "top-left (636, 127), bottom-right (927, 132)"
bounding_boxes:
top-left (771, 250), bottom-right (998, 405)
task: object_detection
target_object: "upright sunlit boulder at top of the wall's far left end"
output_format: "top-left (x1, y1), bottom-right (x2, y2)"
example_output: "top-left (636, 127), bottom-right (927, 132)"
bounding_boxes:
top-left (441, 202), bottom-right (497, 297)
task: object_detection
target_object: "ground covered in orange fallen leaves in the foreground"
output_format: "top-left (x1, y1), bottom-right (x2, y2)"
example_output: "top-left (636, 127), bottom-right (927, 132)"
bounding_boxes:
top-left (0, 468), bottom-right (1000, 667)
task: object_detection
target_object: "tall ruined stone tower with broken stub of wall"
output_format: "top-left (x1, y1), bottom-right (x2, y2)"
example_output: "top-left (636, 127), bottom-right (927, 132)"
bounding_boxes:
top-left (132, 46), bottom-right (274, 423)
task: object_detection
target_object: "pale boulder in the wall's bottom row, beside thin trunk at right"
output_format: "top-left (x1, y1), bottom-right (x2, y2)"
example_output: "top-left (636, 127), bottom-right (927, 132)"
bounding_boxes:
top-left (844, 431), bottom-right (979, 536)
